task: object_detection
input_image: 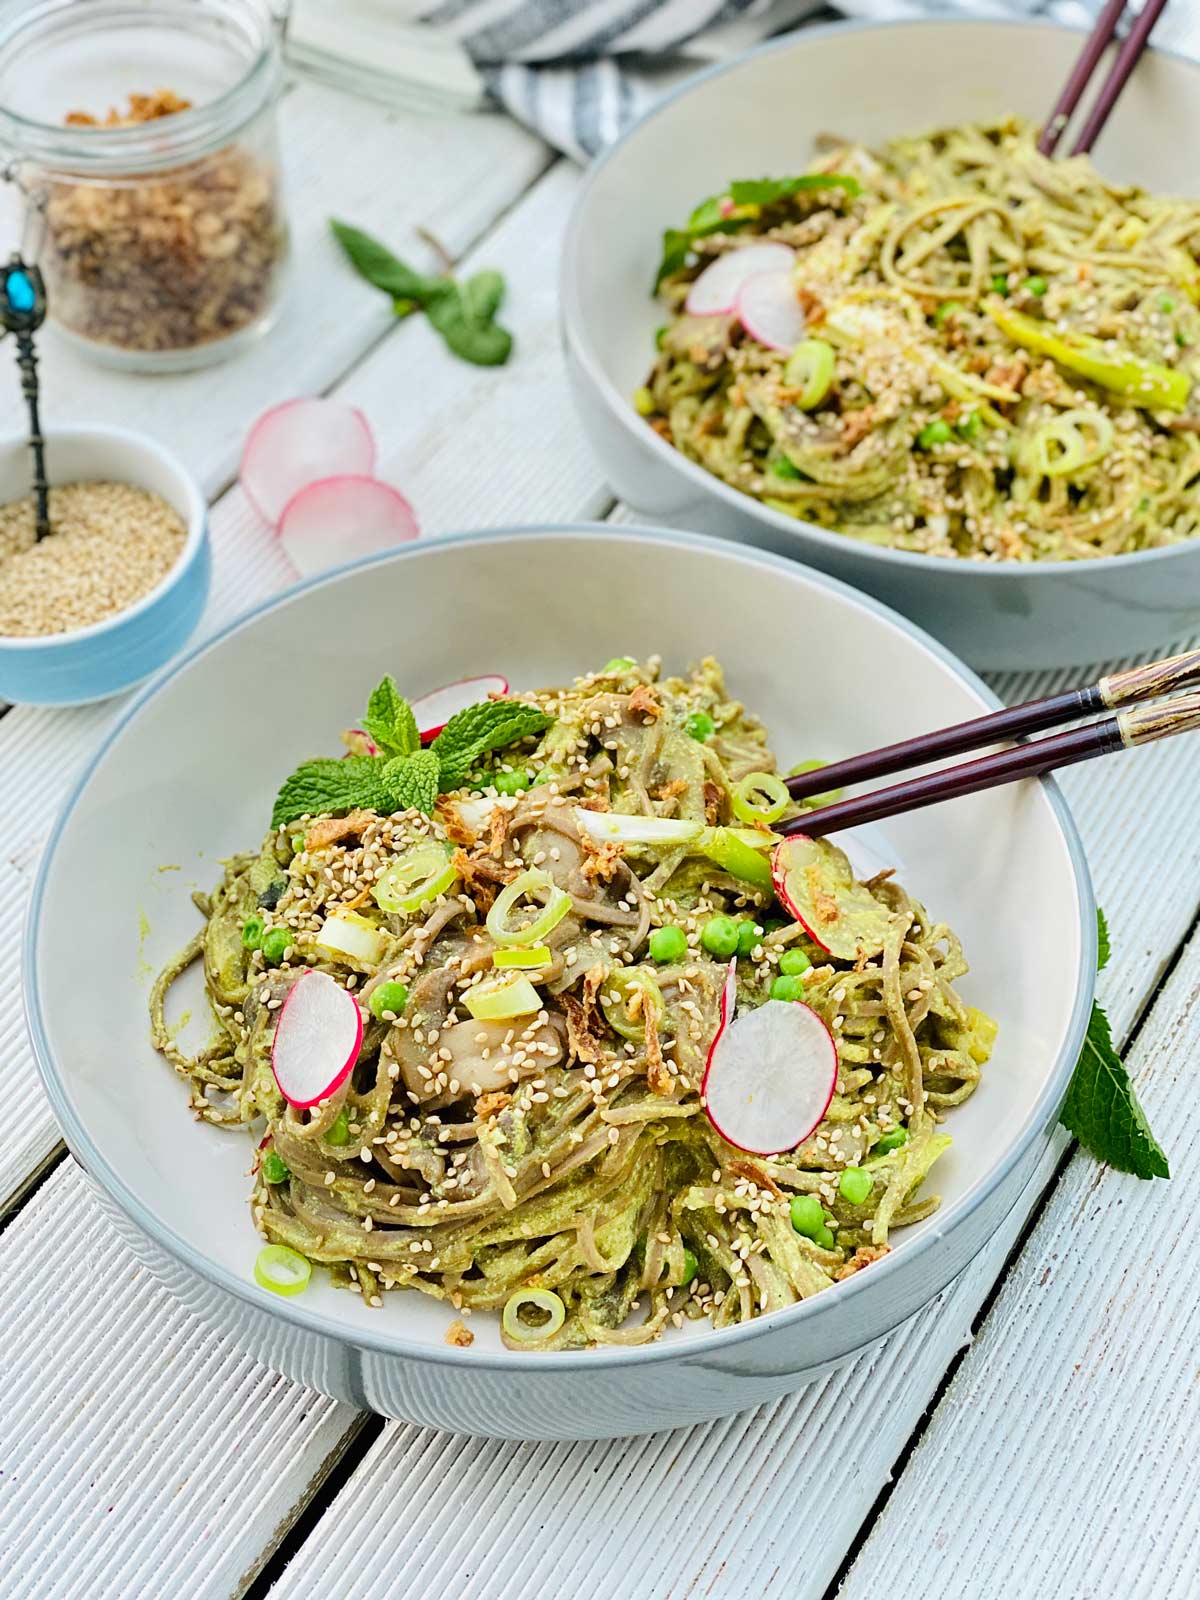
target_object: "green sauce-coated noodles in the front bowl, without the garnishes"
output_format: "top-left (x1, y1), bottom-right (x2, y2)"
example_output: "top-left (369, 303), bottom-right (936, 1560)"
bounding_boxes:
top-left (150, 658), bottom-right (995, 1350)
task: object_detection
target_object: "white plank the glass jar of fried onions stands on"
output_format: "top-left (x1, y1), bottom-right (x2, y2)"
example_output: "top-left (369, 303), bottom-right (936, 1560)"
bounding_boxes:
top-left (0, 82), bottom-right (552, 494)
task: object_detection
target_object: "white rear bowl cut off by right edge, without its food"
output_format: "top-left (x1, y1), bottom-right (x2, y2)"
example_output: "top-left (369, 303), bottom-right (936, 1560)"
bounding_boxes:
top-left (562, 21), bottom-right (1200, 667)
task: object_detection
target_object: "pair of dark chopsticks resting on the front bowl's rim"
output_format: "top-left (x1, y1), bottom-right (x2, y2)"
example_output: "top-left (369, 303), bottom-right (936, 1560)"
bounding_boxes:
top-left (776, 650), bottom-right (1200, 838)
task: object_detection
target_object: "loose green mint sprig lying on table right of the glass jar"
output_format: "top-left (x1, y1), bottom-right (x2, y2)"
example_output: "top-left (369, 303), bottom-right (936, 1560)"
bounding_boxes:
top-left (330, 221), bottom-right (512, 366)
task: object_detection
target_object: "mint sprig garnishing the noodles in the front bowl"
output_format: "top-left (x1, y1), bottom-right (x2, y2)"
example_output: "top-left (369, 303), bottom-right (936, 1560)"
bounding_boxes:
top-left (270, 677), bottom-right (554, 827)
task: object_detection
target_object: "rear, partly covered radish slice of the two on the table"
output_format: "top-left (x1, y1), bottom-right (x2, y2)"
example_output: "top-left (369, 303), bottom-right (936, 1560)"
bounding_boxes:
top-left (238, 395), bottom-right (374, 526)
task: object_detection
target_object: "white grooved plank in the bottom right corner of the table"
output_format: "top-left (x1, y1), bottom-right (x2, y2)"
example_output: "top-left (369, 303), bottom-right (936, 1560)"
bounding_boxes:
top-left (842, 938), bottom-right (1200, 1600)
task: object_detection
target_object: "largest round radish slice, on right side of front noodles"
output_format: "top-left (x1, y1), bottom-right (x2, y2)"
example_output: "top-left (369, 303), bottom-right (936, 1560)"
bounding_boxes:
top-left (701, 1000), bottom-right (837, 1155)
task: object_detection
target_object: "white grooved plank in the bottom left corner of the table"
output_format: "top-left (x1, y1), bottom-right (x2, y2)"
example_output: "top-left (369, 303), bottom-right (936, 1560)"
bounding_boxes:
top-left (0, 1162), bottom-right (357, 1600)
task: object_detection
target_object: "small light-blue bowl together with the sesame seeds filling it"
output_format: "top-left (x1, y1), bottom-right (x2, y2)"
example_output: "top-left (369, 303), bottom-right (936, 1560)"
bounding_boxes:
top-left (0, 427), bottom-right (211, 706)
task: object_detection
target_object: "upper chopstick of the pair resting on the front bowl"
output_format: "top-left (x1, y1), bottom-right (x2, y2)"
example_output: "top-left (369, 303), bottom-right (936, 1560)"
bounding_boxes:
top-left (786, 650), bottom-right (1200, 800)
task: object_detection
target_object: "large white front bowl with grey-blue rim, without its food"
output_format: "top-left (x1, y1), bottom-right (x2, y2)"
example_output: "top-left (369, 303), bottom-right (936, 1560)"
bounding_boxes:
top-left (26, 526), bottom-right (1096, 1438)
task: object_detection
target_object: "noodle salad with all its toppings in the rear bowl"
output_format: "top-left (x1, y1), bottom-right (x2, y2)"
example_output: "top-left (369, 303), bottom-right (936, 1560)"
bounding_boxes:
top-left (635, 120), bottom-right (1200, 562)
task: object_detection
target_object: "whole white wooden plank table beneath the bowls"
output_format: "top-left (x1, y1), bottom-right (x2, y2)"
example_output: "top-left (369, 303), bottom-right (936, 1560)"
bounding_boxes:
top-left (0, 53), bottom-right (1200, 1600)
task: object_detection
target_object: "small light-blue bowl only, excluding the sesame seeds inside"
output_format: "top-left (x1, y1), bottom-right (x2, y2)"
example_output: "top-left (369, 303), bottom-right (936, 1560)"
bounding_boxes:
top-left (0, 427), bottom-right (213, 706)
